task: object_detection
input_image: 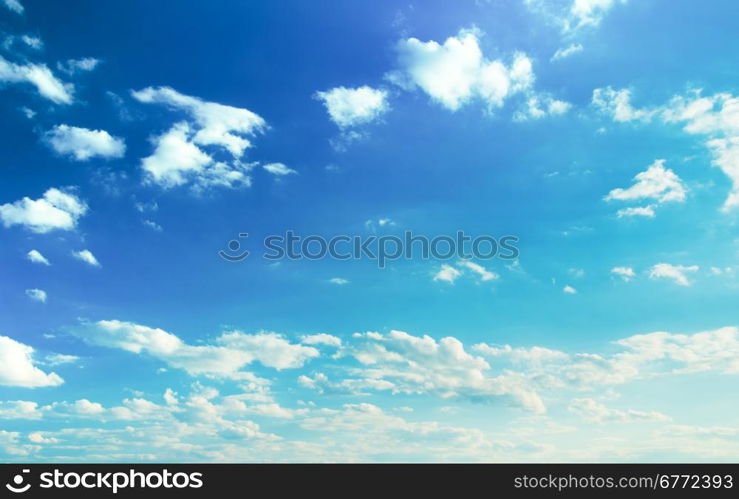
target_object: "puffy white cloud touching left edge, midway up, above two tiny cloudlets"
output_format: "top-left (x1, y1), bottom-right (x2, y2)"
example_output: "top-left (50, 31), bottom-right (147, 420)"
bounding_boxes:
top-left (0, 188), bottom-right (87, 234)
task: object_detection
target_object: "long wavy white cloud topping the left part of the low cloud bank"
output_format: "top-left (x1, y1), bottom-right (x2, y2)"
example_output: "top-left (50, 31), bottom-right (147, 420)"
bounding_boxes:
top-left (72, 320), bottom-right (320, 379)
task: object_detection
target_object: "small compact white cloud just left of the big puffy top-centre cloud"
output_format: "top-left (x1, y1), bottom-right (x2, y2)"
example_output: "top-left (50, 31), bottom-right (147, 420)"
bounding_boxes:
top-left (316, 85), bottom-right (390, 128)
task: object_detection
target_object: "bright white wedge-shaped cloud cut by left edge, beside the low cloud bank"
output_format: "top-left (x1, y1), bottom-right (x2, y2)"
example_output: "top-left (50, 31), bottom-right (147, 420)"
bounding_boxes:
top-left (0, 336), bottom-right (64, 388)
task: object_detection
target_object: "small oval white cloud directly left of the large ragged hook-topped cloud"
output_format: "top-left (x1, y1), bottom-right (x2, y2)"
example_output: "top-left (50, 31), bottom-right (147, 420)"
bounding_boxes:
top-left (45, 125), bottom-right (126, 161)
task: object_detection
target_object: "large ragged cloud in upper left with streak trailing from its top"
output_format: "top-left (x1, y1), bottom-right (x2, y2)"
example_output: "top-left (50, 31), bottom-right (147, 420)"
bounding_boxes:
top-left (132, 87), bottom-right (267, 192)
